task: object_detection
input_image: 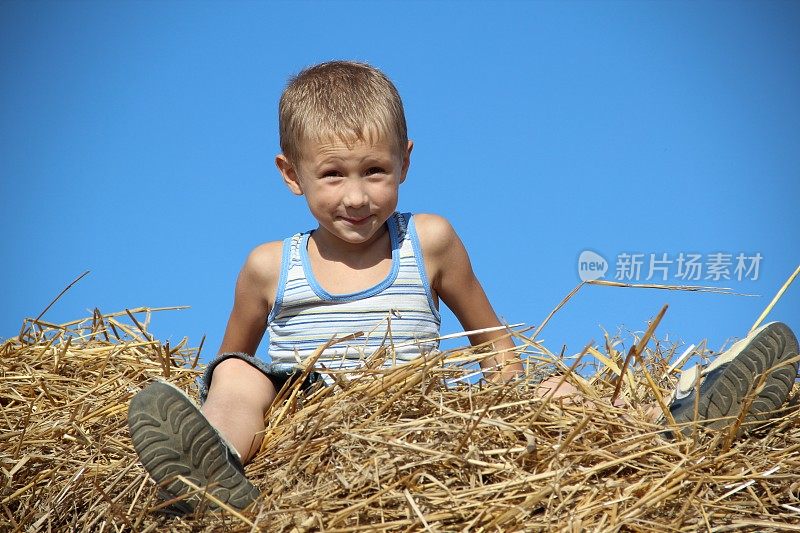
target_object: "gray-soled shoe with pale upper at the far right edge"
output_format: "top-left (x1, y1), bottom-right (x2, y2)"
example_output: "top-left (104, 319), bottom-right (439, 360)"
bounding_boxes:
top-left (661, 322), bottom-right (798, 437)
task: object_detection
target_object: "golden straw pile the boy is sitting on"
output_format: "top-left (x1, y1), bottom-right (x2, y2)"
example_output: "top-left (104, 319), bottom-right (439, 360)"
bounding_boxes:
top-left (0, 309), bottom-right (800, 532)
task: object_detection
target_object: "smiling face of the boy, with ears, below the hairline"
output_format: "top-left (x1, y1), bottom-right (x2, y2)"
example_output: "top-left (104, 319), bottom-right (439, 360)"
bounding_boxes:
top-left (276, 138), bottom-right (413, 244)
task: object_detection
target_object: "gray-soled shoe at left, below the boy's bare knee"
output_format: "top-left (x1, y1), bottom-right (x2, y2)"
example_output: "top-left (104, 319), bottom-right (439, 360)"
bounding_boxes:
top-left (128, 381), bottom-right (259, 511)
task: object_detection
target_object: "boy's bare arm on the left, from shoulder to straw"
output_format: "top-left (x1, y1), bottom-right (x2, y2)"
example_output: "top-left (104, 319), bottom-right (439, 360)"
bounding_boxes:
top-left (219, 241), bottom-right (282, 355)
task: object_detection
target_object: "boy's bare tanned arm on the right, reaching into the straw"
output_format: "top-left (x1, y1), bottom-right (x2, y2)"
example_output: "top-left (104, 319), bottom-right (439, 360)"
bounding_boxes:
top-left (414, 215), bottom-right (523, 381)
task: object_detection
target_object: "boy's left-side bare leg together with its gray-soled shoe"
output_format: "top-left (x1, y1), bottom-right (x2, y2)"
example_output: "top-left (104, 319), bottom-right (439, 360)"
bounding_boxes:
top-left (128, 359), bottom-right (275, 511)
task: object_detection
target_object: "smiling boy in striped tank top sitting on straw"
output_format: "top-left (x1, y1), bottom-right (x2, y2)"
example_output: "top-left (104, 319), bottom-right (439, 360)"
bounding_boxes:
top-left (129, 61), bottom-right (797, 508)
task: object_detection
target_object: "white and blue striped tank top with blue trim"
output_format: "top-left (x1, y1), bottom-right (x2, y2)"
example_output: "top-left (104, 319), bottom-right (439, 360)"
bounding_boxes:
top-left (267, 213), bottom-right (441, 369)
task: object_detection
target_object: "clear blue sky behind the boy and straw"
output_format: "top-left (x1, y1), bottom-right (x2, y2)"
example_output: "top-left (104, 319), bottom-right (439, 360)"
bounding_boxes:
top-left (0, 1), bottom-right (800, 366)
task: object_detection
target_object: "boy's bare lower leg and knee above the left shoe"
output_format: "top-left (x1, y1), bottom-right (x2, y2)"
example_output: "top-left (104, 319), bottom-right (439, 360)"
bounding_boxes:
top-left (202, 358), bottom-right (276, 464)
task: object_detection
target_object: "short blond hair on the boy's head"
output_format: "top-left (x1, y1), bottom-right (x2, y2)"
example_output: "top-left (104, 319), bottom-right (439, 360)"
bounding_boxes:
top-left (278, 61), bottom-right (408, 163)
